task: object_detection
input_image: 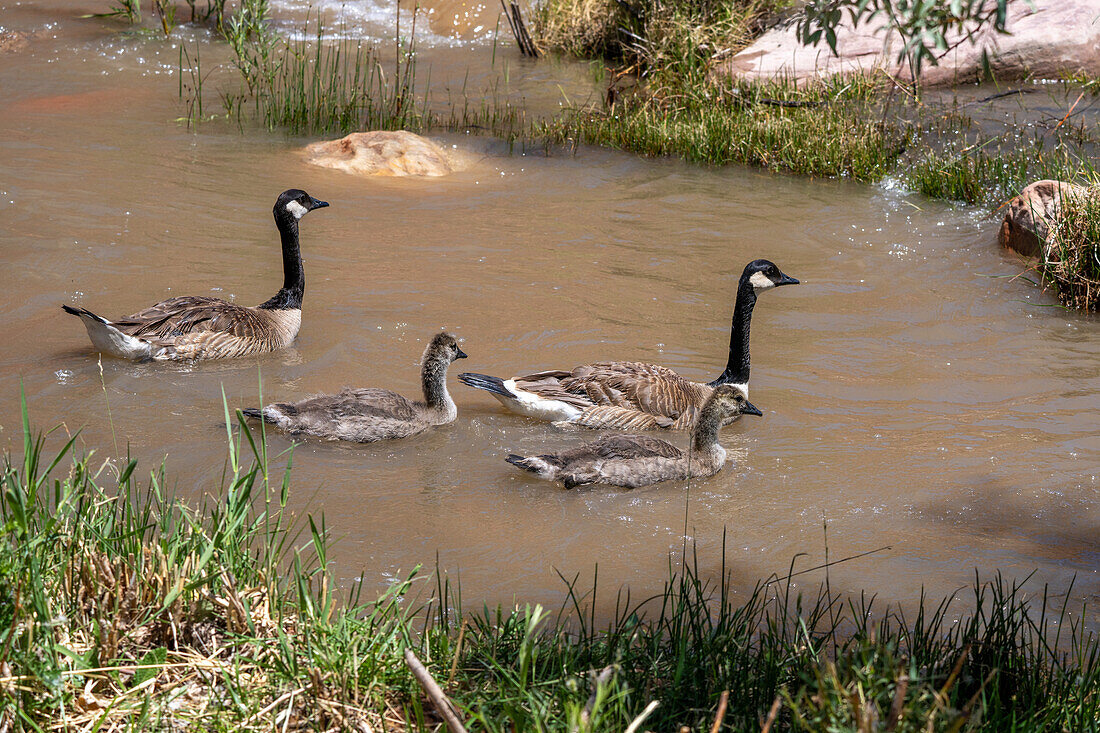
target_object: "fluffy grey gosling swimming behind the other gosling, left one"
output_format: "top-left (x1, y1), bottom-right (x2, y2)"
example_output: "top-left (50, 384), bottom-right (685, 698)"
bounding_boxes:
top-left (241, 332), bottom-right (466, 442)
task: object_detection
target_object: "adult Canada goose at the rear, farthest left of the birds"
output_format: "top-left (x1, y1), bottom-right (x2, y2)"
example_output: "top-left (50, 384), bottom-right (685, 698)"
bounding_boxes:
top-left (62, 188), bottom-right (328, 361)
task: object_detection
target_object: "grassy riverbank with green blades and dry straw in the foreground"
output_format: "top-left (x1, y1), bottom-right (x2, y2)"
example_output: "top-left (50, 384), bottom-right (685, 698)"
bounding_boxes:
top-left (8, 406), bottom-right (1100, 731)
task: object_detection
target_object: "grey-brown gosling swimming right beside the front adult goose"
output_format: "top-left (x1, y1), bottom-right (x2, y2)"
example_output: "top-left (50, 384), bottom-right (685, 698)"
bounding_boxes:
top-left (506, 384), bottom-right (760, 489)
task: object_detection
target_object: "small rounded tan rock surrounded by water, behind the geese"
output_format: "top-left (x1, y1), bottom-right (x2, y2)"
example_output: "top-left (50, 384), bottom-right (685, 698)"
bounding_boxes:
top-left (306, 130), bottom-right (454, 176)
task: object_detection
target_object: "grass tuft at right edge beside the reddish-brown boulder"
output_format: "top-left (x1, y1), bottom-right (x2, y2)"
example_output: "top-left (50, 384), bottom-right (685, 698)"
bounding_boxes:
top-left (1042, 186), bottom-right (1100, 311)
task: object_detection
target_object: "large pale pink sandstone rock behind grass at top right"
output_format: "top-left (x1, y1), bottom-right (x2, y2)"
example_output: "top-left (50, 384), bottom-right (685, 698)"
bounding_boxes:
top-left (714, 0), bottom-right (1100, 86)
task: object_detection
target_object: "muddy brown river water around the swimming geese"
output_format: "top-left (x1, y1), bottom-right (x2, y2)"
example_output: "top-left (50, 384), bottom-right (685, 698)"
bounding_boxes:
top-left (0, 2), bottom-right (1100, 620)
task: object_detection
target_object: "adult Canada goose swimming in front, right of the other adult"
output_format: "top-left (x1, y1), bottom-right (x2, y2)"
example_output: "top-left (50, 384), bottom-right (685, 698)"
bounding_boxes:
top-left (459, 260), bottom-right (799, 430)
